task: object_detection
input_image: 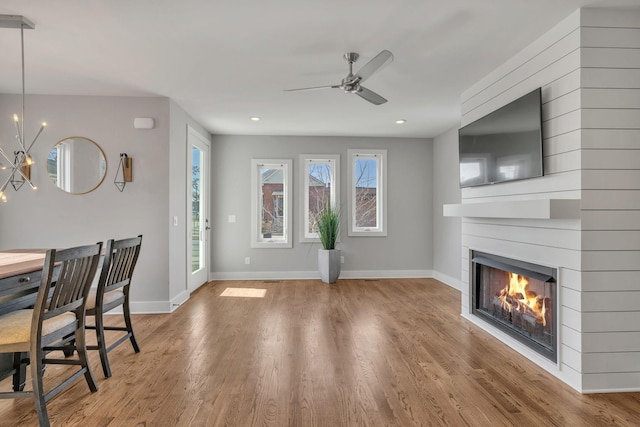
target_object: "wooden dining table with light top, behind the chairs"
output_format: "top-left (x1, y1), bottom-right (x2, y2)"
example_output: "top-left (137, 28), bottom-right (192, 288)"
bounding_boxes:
top-left (0, 249), bottom-right (46, 390)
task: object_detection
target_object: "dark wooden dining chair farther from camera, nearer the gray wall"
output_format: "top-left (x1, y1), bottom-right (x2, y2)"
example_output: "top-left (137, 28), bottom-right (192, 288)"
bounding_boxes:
top-left (87, 235), bottom-right (142, 377)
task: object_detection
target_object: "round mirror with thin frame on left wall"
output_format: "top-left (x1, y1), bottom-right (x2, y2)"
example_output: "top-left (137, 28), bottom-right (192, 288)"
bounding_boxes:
top-left (47, 136), bottom-right (107, 194)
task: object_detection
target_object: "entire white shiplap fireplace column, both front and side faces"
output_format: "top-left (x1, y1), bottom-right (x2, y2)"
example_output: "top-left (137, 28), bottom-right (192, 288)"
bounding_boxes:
top-left (461, 9), bottom-right (640, 392)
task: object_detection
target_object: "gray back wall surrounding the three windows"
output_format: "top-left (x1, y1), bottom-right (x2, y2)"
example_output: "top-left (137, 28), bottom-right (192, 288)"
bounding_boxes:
top-left (212, 135), bottom-right (433, 278)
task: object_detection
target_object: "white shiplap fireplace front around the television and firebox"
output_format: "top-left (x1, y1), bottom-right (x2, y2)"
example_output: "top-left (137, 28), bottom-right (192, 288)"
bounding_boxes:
top-left (462, 9), bottom-right (582, 390)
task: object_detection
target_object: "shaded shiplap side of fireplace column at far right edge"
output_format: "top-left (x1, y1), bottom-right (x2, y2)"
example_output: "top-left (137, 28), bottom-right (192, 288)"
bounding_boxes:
top-left (581, 9), bottom-right (640, 392)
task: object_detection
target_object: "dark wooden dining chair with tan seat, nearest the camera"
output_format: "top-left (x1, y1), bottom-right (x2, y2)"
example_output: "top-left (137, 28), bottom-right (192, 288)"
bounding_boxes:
top-left (0, 243), bottom-right (102, 426)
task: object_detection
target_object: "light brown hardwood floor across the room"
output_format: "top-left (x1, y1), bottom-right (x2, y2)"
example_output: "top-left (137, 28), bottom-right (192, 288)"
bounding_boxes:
top-left (0, 279), bottom-right (640, 426)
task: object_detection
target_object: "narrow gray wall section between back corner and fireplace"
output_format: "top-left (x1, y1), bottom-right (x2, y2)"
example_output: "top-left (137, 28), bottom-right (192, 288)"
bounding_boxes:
top-left (433, 128), bottom-right (462, 288)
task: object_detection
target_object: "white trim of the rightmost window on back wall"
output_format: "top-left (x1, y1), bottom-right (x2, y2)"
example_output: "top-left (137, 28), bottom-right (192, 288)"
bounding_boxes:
top-left (347, 149), bottom-right (387, 236)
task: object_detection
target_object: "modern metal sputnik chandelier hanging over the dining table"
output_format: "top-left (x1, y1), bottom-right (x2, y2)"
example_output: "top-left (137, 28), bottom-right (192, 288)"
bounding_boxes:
top-left (0, 15), bottom-right (47, 202)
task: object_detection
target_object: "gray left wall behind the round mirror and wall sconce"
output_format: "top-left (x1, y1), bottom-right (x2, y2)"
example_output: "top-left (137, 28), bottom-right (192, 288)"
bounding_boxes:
top-left (0, 95), bottom-right (169, 307)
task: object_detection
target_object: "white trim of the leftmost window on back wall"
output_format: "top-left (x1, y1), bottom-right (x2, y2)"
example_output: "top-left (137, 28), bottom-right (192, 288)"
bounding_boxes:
top-left (251, 159), bottom-right (293, 249)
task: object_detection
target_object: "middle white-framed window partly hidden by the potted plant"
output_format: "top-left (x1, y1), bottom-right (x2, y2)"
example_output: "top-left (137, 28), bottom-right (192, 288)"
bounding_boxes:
top-left (300, 154), bottom-right (340, 242)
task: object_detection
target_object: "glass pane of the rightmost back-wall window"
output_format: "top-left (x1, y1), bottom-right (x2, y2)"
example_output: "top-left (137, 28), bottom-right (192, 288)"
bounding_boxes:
top-left (353, 157), bottom-right (378, 228)
